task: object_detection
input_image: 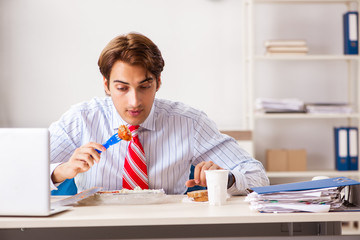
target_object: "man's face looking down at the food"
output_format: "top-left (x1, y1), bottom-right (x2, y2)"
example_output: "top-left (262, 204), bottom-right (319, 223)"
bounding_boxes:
top-left (104, 61), bottom-right (160, 125)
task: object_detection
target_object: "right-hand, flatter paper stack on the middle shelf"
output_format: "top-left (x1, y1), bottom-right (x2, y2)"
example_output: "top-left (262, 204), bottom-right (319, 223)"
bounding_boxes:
top-left (306, 103), bottom-right (353, 114)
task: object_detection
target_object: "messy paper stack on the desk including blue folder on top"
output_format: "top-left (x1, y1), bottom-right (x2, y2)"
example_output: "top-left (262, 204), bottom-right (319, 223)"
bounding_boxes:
top-left (245, 177), bottom-right (360, 213)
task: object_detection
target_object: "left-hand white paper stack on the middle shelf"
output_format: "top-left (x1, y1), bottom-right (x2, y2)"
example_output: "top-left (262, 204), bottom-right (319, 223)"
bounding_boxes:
top-left (255, 98), bottom-right (304, 113)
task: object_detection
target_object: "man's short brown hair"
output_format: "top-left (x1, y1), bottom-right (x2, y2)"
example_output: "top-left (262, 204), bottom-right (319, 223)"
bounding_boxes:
top-left (98, 33), bottom-right (165, 89)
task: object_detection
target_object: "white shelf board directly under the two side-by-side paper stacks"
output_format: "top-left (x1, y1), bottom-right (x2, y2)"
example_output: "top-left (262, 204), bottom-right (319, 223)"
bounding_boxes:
top-left (254, 113), bottom-right (360, 119)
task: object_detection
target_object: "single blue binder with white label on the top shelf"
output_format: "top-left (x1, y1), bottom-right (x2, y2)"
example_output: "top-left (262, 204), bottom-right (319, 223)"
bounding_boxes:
top-left (343, 11), bottom-right (359, 55)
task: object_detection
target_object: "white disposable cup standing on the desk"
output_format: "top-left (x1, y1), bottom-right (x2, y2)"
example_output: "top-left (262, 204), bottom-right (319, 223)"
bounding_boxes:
top-left (205, 169), bottom-right (229, 205)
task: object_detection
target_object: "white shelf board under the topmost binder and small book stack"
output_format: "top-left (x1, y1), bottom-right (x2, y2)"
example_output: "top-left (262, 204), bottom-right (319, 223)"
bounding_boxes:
top-left (252, 54), bottom-right (360, 61)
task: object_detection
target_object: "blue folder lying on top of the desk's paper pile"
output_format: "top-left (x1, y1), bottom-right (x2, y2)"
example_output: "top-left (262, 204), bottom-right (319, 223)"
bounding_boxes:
top-left (251, 177), bottom-right (360, 194)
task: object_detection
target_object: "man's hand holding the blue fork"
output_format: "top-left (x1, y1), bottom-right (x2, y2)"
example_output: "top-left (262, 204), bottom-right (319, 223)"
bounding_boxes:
top-left (51, 142), bottom-right (106, 183)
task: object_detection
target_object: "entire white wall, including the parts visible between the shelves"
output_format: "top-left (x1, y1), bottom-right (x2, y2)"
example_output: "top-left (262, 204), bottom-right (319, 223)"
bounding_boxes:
top-left (0, 0), bottom-right (354, 169)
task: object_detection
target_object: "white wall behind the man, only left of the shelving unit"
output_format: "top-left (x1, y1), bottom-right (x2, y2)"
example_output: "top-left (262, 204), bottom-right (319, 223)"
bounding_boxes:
top-left (0, 0), bottom-right (241, 129)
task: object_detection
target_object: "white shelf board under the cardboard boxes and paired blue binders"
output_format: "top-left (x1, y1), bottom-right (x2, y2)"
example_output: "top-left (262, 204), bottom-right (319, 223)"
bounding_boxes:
top-left (266, 170), bottom-right (360, 178)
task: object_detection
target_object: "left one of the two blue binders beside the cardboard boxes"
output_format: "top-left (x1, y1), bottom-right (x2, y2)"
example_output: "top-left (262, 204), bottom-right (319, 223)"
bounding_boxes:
top-left (334, 127), bottom-right (349, 171)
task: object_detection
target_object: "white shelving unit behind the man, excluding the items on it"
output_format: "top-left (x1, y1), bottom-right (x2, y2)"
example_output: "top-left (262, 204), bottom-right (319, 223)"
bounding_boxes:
top-left (243, 0), bottom-right (360, 180)
